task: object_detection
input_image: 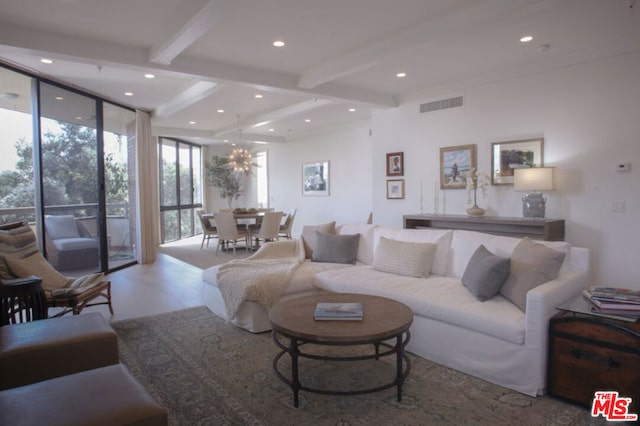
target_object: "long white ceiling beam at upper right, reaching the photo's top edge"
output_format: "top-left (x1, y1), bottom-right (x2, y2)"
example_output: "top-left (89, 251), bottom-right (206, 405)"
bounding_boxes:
top-left (298, 0), bottom-right (541, 89)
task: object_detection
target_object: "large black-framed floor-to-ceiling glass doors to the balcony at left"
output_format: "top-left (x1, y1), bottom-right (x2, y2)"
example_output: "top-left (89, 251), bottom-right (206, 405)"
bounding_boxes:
top-left (0, 66), bottom-right (135, 275)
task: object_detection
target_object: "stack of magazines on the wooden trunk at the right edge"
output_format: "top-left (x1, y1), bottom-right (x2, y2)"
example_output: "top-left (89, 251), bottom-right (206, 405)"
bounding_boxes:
top-left (583, 287), bottom-right (640, 318)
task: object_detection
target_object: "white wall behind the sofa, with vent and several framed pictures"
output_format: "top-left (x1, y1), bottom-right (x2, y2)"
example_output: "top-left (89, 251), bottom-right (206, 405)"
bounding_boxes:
top-left (372, 53), bottom-right (640, 288)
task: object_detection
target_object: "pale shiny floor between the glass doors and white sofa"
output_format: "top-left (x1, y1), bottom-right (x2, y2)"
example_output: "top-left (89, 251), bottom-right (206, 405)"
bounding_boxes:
top-left (89, 253), bottom-right (204, 321)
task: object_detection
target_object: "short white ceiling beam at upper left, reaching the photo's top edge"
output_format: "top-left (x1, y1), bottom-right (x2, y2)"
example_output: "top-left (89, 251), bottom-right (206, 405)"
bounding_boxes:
top-left (149, 0), bottom-right (242, 65)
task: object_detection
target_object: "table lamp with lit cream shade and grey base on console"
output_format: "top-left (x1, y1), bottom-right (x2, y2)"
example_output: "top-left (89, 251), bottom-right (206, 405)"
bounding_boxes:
top-left (513, 167), bottom-right (555, 219)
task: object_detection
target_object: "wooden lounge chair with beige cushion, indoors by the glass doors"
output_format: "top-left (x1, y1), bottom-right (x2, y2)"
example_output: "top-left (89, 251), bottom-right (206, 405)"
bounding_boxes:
top-left (0, 222), bottom-right (113, 316)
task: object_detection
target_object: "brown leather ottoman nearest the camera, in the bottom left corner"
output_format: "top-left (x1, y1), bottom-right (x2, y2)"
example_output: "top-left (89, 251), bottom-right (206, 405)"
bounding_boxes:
top-left (0, 364), bottom-right (167, 426)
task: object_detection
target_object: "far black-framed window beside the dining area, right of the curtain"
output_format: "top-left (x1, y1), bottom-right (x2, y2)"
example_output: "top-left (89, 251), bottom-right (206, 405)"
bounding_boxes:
top-left (159, 138), bottom-right (202, 243)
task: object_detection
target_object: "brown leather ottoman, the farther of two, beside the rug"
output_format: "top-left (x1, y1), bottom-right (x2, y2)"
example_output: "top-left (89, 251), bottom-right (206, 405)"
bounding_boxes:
top-left (0, 312), bottom-right (120, 390)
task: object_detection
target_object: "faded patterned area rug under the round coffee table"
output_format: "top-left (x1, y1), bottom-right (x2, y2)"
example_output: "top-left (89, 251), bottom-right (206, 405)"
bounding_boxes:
top-left (112, 306), bottom-right (604, 426)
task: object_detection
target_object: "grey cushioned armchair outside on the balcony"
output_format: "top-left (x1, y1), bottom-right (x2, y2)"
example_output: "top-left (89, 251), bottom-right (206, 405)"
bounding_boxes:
top-left (44, 215), bottom-right (100, 271)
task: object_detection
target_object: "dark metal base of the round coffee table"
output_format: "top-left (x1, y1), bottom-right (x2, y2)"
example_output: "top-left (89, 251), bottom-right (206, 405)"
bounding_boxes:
top-left (271, 329), bottom-right (411, 407)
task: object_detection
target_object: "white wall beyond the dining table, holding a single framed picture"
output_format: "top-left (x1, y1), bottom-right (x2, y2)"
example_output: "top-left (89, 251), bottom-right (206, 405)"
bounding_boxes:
top-left (268, 121), bottom-right (372, 234)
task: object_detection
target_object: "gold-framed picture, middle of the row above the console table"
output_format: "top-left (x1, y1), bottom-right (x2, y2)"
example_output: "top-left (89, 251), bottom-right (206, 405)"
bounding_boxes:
top-left (440, 144), bottom-right (476, 189)
